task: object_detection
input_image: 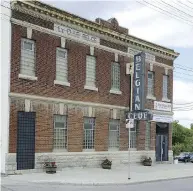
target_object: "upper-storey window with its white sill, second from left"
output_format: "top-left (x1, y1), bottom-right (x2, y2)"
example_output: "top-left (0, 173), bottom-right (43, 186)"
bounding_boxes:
top-left (54, 47), bottom-right (70, 86)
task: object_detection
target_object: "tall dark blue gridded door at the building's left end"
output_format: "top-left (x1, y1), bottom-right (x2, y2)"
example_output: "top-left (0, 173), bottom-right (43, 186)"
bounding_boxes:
top-left (17, 112), bottom-right (35, 170)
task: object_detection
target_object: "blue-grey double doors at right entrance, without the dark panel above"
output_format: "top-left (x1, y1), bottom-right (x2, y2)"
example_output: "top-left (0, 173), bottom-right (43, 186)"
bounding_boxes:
top-left (156, 135), bottom-right (168, 161)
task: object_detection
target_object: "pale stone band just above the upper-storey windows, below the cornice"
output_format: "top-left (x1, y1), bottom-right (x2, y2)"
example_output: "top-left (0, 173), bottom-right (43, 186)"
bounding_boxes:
top-left (11, 18), bottom-right (173, 69)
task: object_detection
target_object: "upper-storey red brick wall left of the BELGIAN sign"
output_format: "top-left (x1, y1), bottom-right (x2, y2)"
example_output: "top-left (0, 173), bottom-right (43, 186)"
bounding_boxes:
top-left (11, 25), bottom-right (130, 106)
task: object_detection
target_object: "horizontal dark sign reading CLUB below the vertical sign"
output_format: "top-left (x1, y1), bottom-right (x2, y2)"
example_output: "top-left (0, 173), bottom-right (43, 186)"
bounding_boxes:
top-left (126, 111), bottom-right (153, 121)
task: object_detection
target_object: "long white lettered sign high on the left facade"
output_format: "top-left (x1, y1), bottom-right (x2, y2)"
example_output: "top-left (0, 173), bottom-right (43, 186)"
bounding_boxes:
top-left (54, 24), bottom-right (100, 44)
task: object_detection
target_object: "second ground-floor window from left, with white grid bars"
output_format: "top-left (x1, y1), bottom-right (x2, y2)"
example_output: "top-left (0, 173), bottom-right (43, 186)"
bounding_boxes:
top-left (83, 117), bottom-right (95, 150)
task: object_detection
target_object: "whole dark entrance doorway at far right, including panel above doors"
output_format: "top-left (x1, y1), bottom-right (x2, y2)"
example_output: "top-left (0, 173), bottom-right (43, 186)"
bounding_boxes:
top-left (156, 123), bottom-right (169, 161)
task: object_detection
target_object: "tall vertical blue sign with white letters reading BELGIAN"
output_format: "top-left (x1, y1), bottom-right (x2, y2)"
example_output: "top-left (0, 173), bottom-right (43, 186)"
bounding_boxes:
top-left (133, 52), bottom-right (145, 111)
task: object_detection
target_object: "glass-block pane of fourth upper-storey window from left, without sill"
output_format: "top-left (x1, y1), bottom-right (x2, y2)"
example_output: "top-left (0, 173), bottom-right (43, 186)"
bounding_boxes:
top-left (111, 62), bottom-right (120, 91)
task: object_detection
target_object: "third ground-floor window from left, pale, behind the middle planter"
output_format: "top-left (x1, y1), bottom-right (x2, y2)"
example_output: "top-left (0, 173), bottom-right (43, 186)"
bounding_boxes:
top-left (108, 119), bottom-right (120, 150)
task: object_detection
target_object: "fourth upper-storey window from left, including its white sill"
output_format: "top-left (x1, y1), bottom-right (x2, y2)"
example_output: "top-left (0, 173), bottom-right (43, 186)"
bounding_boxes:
top-left (110, 62), bottom-right (122, 94)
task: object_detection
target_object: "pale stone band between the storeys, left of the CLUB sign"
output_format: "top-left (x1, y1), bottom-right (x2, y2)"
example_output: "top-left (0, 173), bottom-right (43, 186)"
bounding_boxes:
top-left (9, 92), bottom-right (129, 110)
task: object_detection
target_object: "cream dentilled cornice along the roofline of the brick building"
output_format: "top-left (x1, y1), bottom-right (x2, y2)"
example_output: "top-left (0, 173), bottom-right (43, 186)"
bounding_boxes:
top-left (13, 2), bottom-right (177, 60)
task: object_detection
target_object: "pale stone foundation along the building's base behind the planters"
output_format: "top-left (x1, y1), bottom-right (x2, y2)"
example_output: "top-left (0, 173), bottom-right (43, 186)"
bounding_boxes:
top-left (6, 151), bottom-right (158, 174)
